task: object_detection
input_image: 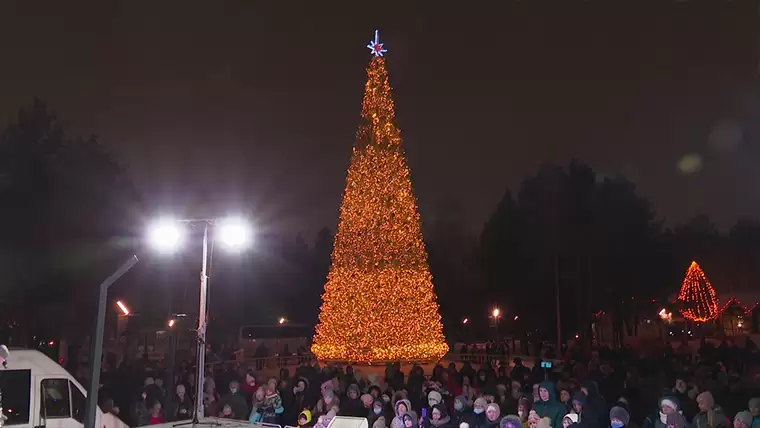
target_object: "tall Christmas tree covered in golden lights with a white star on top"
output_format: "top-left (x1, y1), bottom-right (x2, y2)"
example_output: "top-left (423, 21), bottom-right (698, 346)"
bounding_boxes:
top-left (311, 32), bottom-right (448, 362)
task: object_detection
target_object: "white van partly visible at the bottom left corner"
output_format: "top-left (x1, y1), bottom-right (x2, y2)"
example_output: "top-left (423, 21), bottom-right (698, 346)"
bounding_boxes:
top-left (0, 349), bottom-right (128, 428)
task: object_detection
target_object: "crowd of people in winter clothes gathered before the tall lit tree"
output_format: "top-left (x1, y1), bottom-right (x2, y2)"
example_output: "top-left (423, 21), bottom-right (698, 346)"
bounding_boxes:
top-left (96, 336), bottom-right (760, 428)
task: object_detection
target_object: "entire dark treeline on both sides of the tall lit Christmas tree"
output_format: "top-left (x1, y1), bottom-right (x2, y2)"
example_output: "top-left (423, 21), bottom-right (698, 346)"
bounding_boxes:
top-left (0, 100), bottom-right (760, 350)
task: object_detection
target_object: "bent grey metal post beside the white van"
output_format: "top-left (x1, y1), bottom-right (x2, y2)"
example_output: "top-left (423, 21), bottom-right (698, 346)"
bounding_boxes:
top-left (84, 255), bottom-right (138, 428)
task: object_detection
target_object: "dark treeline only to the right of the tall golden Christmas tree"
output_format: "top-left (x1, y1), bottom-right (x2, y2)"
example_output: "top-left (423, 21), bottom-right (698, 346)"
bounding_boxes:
top-left (429, 161), bottom-right (760, 342)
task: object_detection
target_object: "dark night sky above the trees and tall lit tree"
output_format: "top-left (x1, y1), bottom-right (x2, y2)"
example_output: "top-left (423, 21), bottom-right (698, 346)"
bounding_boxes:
top-left (0, 0), bottom-right (760, 240)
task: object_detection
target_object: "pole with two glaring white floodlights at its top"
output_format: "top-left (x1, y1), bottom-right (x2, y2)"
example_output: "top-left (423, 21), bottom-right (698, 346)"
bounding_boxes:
top-left (148, 217), bottom-right (253, 423)
